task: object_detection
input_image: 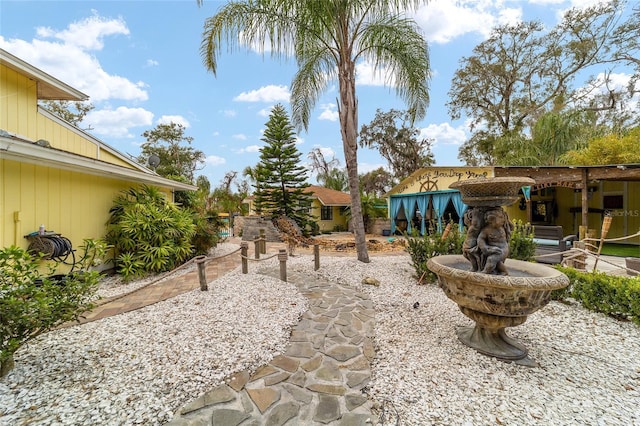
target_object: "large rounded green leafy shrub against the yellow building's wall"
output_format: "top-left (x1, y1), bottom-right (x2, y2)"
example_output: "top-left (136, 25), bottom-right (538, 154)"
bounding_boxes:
top-left (106, 185), bottom-right (196, 279)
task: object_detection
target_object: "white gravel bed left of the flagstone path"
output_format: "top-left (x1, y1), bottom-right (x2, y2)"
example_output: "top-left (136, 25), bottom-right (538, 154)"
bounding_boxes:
top-left (0, 246), bottom-right (308, 426)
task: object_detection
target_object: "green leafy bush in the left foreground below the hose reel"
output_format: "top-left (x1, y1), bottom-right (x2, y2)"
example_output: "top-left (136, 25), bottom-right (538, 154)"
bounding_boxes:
top-left (0, 246), bottom-right (100, 377)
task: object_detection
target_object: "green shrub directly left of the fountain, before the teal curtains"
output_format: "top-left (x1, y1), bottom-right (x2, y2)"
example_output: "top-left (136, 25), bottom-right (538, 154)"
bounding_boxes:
top-left (407, 222), bottom-right (466, 282)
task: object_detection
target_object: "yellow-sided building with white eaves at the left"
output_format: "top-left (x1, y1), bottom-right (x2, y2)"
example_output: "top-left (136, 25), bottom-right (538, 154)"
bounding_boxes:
top-left (0, 49), bottom-right (197, 262)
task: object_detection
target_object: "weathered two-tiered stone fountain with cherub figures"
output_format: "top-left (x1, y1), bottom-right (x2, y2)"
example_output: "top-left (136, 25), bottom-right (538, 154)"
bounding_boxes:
top-left (427, 177), bottom-right (569, 366)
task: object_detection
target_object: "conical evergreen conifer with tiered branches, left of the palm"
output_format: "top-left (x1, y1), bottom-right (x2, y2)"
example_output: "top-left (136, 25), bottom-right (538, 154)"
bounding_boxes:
top-left (254, 104), bottom-right (311, 229)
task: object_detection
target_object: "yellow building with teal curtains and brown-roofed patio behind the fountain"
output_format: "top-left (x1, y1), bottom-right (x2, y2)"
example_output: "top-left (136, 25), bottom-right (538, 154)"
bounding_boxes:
top-left (386, 164), bottom-right (640, 245)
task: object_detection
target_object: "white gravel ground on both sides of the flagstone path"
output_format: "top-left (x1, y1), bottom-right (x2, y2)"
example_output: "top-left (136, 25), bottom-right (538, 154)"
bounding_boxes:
top-left (0, 246), bottom-right (640, 426)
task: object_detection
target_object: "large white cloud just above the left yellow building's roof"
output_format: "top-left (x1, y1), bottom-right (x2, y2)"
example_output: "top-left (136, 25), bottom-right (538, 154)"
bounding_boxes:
top-left (0, 16), bottom-right (149, 102)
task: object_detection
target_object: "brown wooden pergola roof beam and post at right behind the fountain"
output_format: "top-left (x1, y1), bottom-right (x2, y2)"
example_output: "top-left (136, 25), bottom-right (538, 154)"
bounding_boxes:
top-left (494, 164), bottom-right (640, 228)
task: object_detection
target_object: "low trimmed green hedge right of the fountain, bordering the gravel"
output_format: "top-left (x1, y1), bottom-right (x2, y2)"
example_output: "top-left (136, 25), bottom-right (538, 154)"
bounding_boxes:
top-left (552, 266), bottom-right (640, 325)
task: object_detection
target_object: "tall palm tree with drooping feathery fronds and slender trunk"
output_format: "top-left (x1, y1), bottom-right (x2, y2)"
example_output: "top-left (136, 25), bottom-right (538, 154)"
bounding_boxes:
top-left (198, 0), bottom-right (430, 262)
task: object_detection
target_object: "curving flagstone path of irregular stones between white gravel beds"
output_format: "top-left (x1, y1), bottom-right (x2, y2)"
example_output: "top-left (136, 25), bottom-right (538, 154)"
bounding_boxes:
top-left (168, 269), bottom-right (375, 426)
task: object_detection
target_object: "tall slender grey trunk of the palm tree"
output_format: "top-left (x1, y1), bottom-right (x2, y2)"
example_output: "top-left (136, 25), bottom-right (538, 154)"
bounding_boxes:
top-left (338, 62), bottom-right (369, 263)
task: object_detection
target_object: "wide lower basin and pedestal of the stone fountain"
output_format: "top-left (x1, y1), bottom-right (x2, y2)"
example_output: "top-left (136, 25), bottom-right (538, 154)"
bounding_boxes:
top-left (427, 255), bottom-right (569, 365)
